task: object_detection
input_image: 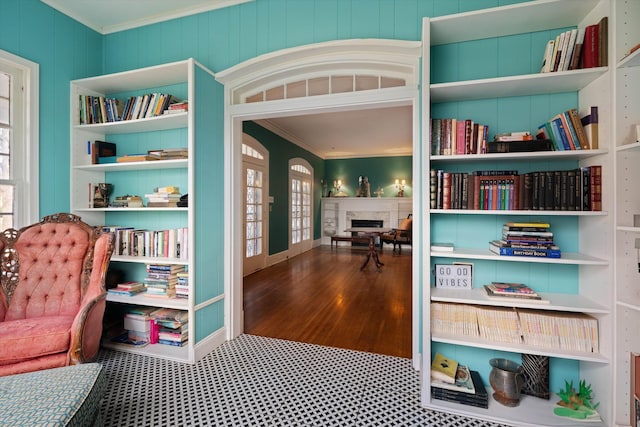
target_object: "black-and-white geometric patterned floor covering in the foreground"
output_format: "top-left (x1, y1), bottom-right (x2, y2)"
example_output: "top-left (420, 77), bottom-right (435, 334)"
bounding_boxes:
top-left (97, 335), bottom-right (498, 427)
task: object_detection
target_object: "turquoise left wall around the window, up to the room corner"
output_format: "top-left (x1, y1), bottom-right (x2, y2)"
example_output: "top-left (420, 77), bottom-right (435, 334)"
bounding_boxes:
top-left (0, 0), bottom-right (104, 216)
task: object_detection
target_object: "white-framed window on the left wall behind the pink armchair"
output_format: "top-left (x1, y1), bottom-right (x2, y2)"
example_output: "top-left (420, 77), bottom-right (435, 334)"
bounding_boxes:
top-left (0, 50), bottom-right (39, 230)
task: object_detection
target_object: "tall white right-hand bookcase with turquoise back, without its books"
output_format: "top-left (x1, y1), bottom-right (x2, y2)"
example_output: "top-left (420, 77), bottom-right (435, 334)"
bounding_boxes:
top-left (420, 0), bottom-right (612, 426)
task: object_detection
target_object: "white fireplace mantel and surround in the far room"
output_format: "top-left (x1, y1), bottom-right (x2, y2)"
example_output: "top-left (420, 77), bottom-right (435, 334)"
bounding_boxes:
top-left (321, 197), bottom-right (413, 245)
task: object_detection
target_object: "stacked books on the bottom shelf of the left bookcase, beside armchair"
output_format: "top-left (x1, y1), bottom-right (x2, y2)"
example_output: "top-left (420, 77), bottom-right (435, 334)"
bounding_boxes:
top-left (111, 306), bottom-right (189, 347)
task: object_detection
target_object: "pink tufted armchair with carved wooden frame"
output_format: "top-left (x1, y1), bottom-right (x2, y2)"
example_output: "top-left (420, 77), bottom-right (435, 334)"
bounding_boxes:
top-left (0, 213), bottom-right (113, 376)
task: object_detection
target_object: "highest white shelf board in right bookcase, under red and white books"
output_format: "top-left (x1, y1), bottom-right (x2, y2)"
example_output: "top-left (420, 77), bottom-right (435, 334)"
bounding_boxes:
top-left (429, 67), bottom-right (608, 103)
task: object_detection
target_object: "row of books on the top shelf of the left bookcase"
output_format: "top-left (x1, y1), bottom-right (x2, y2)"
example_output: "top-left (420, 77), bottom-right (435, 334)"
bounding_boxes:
top-left (80, 92), bottom-right (179, 125)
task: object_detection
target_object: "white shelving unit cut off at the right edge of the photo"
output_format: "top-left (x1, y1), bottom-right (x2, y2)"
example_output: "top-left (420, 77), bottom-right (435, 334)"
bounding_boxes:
top-left (610, 0), bottom-right (640, 426)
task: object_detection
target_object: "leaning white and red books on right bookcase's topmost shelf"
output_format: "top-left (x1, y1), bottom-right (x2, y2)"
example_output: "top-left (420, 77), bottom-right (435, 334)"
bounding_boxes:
top-left (540, 16), bottom-right (608, 73)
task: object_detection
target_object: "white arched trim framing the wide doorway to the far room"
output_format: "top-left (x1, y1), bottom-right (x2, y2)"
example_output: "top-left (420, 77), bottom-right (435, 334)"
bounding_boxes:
top-left (216, 40), bottom-right (428, 369)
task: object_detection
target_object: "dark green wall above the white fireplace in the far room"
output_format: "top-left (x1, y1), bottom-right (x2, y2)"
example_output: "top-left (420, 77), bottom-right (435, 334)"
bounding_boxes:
top-left (324, 156), bottom-right (413, 197)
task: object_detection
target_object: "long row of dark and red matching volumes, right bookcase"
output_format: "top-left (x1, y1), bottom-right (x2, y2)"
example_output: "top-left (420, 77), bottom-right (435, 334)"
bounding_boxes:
top-left (429, 165), bottom-right (602, 211)
